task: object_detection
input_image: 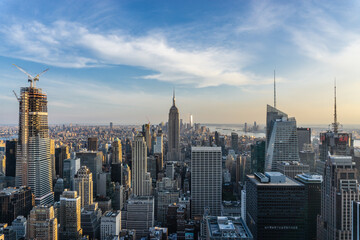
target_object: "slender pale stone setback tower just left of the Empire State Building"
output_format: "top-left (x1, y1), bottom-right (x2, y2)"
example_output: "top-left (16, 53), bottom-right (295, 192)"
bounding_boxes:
top-left (132, 135), bottom-right (151, 196)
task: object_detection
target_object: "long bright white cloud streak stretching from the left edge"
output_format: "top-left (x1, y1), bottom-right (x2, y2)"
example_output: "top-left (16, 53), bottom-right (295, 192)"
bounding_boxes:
top-left (0, 21), bottom-right (262, 87)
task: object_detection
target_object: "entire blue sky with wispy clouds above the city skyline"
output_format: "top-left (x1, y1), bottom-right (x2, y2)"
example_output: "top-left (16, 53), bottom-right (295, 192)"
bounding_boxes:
top-left (0, 0), bottom-right (360, 125)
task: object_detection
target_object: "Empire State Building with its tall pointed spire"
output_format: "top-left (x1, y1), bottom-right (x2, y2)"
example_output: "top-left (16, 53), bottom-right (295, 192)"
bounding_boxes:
top-left (167, 91), bottom-right (181, 161)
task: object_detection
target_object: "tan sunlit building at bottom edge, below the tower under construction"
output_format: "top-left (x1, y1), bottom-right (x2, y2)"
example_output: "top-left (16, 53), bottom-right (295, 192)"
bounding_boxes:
top-left (28, 205), bottom-right (58, 240)
